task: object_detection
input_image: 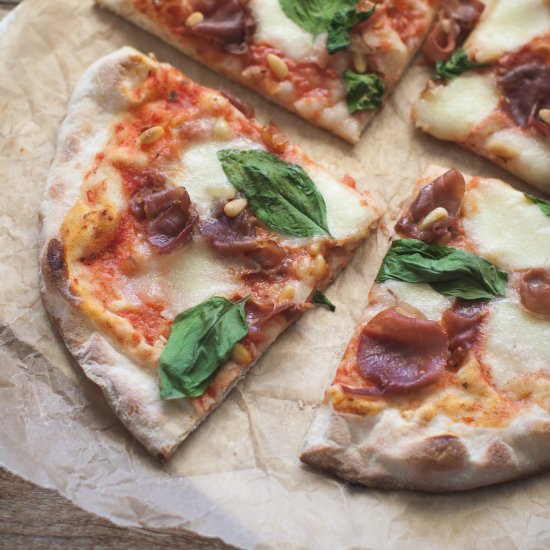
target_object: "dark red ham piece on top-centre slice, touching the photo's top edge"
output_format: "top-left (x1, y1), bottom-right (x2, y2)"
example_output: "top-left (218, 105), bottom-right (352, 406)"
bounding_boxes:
top-left (187, 0), bottom-right (256, 54)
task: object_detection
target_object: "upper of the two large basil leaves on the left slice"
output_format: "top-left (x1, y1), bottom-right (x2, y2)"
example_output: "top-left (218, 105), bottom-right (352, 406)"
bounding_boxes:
top-left (218, 149), bottom-right (330, 237)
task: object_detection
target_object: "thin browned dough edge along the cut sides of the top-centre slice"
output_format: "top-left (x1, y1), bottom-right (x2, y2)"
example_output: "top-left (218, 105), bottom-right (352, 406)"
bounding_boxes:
top-left (95, 0), bottom-right (435, 143)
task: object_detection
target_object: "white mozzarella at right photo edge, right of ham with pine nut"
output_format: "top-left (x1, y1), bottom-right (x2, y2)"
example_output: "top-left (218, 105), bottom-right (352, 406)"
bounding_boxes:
top-left (463, 180), bottom-right (550, 269)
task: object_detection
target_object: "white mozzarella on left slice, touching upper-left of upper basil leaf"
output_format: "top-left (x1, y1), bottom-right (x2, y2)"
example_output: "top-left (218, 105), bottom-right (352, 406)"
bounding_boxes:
top-left (171, 138), bottom-right (258, 216)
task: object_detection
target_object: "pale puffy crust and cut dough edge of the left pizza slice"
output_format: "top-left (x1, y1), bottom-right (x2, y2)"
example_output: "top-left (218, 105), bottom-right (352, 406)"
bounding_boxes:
top-left (40, 47), bottom-right (379, 459)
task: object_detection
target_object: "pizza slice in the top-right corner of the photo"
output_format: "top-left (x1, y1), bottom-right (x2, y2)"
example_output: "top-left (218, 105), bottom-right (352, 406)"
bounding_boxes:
top-left (413, 0), bottom-right (550, 192)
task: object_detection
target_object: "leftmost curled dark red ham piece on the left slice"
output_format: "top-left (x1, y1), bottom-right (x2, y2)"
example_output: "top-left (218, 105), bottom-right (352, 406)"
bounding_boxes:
top-left (136, 187), bottom-right (198, 254)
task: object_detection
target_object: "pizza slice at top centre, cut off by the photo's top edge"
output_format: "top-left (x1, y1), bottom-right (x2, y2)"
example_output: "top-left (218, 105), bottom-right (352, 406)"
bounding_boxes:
top-left (96, 0), bottom-right (435, 143)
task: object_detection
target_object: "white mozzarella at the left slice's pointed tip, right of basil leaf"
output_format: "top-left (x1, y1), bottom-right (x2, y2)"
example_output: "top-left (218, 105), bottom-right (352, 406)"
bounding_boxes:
top-left (307, 167), bottom-right (376, 240)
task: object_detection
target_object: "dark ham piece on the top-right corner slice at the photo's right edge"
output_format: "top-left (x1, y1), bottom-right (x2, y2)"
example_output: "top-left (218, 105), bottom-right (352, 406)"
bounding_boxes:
top-left (497, 62), bottom-right (550, 133)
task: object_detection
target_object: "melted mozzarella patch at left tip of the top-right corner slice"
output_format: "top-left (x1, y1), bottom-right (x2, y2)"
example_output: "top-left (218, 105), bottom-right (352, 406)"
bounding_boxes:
top-left (414, 73), bottom-right (500, 141)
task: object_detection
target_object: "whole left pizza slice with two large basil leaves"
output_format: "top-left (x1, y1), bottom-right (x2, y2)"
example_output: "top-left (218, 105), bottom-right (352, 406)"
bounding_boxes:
top-left (40, 47), bottom-right (381, 459)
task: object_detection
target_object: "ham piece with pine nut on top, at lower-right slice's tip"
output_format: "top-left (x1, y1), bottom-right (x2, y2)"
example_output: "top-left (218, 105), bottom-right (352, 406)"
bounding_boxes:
top-left (395, 168), bottom-right (466, 243)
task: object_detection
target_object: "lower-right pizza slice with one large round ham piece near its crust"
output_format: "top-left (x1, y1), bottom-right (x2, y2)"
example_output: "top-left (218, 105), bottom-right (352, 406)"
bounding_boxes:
top-left (301, 167), bottom-right (550, 491)
